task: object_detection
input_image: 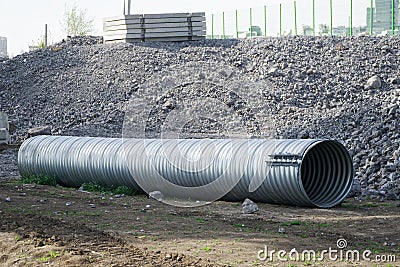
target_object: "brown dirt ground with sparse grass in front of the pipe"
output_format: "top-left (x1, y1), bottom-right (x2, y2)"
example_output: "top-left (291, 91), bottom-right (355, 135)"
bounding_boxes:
top-left (0, 180), bottom-right (400, 266)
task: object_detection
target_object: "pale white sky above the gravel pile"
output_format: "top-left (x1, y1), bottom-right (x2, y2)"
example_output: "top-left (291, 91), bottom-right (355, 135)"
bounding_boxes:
top-left (0, 0), bottom-right (370, 56)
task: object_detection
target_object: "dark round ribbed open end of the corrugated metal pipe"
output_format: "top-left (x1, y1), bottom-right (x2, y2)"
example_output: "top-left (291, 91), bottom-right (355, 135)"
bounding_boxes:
top-left (300, 140), bottom-right (354, 208)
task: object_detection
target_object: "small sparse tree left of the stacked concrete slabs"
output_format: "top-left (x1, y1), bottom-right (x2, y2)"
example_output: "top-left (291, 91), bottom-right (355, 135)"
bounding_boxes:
top-left (62, 6), bottom-right (94, 36)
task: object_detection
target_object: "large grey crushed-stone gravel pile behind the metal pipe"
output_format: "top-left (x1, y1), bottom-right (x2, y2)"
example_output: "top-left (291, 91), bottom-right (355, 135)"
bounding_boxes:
top-left (0, 37), bottom-right (400, 199)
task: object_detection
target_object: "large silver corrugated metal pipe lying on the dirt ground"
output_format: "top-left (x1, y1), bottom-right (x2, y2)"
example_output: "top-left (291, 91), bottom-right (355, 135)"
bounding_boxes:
top-left (18, 136), bottom-right (354, 208)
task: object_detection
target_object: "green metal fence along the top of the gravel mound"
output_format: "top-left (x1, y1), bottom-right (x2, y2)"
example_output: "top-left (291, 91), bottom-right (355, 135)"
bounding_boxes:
top-left (207, 0), bottom-right (400, 38)
